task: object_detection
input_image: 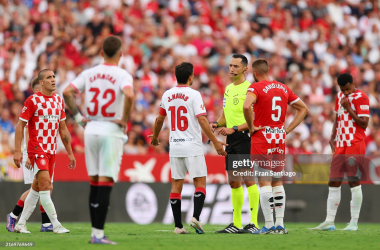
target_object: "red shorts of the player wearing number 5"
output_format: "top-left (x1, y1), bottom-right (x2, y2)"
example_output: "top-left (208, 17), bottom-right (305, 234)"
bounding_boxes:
top-left (251, 143), bottom-right (285, 172)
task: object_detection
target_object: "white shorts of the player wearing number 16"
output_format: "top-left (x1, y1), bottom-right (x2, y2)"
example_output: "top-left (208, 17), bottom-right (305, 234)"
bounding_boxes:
top-left (170, 155), bottom-right (207, 180)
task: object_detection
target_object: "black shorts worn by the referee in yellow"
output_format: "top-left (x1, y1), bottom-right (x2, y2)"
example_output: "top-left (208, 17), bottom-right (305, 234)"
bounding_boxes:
top-left (226, 130), bottom-right (251, 170)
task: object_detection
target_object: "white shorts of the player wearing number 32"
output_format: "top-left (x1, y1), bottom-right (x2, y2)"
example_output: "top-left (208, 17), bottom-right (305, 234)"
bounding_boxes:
top-left (84, 133), bottom-right (124, 182)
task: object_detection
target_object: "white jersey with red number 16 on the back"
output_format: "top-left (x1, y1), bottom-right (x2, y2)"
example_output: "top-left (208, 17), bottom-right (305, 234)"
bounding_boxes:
top-left (160, 86), bottom-right (207, 157)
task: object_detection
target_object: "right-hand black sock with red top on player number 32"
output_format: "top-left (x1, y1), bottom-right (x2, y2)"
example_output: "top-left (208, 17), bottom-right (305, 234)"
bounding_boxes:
top-left (94, 182), bottom-right (113, 239)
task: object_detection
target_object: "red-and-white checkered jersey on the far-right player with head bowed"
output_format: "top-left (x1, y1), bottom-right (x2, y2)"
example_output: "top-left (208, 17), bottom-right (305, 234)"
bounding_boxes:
top-left (334, 89), bottom-right (369, 147)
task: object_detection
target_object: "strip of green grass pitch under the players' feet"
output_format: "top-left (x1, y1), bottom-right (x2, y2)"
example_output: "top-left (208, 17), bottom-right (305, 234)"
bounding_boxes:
top-left (0, 223), bottom-right (380, 250)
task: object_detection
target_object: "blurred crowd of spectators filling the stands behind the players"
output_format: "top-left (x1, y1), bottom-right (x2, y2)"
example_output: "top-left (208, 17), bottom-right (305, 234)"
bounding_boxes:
top-left (0, 0), bottom-right (380, 155)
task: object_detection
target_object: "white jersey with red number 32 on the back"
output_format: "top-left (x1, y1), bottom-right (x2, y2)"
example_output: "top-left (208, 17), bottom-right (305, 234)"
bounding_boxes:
top-left (71, 63), bottom-right (133, 137)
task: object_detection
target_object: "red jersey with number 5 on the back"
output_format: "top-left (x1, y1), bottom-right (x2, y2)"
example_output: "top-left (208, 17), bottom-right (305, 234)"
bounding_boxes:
top-left (247, 81), bottom-right (299, 144)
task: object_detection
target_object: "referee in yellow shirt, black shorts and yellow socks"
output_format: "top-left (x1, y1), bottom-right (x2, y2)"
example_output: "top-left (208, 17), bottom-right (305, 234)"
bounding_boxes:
top-left (211, 54), bottom-right (260, 233)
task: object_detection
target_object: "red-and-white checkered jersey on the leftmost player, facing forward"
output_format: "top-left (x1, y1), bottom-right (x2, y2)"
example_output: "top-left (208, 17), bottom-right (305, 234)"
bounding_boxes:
top-left (20, 92), bottom-right (66, 154)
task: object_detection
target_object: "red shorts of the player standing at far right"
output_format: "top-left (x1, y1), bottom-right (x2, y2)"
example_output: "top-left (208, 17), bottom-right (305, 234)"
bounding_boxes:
top-left (330, 141), bottom-right (366, 179)
